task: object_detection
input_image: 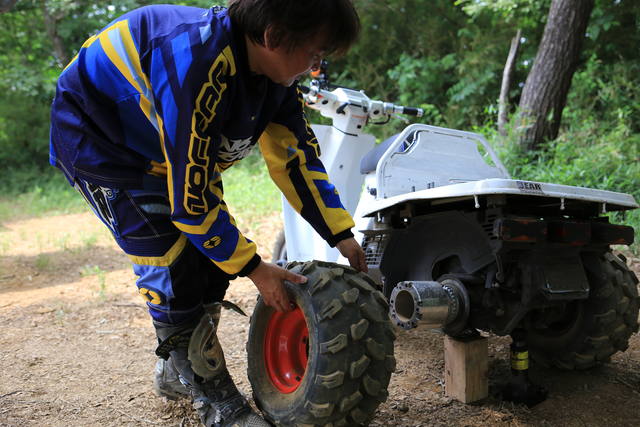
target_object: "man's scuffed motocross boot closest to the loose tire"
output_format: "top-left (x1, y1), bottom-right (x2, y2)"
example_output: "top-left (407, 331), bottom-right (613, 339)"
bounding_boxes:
top-left (154, 304), bottom-right (270, 427)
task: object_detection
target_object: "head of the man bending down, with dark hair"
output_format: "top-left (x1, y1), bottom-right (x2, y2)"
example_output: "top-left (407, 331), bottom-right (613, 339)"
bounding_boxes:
top-left (229, 0), bottom-right (360, 86)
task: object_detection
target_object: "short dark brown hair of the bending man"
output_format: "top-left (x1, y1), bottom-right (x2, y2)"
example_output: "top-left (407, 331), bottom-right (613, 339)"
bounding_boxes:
top-left (229, 0), bottom-right (360, 54)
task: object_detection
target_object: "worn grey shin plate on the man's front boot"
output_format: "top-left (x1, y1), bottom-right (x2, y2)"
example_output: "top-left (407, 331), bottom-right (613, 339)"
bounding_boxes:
top-left (188, 303), bottom-right (226, 380)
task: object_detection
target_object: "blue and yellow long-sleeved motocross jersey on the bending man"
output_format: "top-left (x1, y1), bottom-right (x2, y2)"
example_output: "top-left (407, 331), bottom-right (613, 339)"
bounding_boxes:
top-left (50, 6), bottom-right (353, 275)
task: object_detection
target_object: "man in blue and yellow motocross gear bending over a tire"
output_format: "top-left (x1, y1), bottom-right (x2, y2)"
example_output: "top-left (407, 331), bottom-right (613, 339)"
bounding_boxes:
top-left (50, 0), bottom-right (366, 426)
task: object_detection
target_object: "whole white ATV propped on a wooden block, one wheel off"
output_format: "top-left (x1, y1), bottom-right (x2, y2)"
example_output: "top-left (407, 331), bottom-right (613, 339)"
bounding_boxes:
top-left (275, 80), bottom-right (640, 368)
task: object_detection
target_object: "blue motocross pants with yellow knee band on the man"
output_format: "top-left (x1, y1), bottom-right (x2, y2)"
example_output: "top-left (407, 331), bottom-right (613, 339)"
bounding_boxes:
top-left (75, 179), bottom-right (236, 324)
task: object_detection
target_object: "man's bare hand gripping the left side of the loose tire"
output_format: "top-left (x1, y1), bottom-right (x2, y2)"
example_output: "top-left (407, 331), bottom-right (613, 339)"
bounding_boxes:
top-left (249, 262), bottom-right (308, 312)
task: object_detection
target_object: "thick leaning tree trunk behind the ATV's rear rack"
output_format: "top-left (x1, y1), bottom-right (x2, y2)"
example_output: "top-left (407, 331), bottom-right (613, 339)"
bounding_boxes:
top-left (519, 0), bottom-right (594, 150)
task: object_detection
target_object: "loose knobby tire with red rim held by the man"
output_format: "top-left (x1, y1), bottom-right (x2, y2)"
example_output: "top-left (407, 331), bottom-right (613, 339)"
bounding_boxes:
top-left (247, 261), bottom-right (396, 427)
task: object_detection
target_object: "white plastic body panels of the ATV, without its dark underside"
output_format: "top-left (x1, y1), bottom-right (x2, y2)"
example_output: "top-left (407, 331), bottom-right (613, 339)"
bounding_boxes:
top-left (283, 88), bottom-right (638, 263)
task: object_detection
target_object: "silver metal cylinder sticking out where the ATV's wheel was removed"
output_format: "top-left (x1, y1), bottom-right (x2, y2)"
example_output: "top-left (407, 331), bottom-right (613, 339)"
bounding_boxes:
top-left (389, 278), bottom-right (469, 335)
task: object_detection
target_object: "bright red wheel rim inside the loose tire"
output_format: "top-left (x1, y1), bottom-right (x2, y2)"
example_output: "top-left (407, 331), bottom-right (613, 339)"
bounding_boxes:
top-left (264, 307), bottom-right (309, 393)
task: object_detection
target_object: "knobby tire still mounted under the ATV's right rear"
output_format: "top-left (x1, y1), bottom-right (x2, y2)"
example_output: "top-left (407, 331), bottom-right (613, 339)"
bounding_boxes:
top-left (528, 252), bottom-right (640, 369)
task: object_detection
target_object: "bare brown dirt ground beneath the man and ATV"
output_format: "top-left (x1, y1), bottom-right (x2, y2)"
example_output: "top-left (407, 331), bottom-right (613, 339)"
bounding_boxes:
top-left (0, 213), bottom-right (640, 426)
